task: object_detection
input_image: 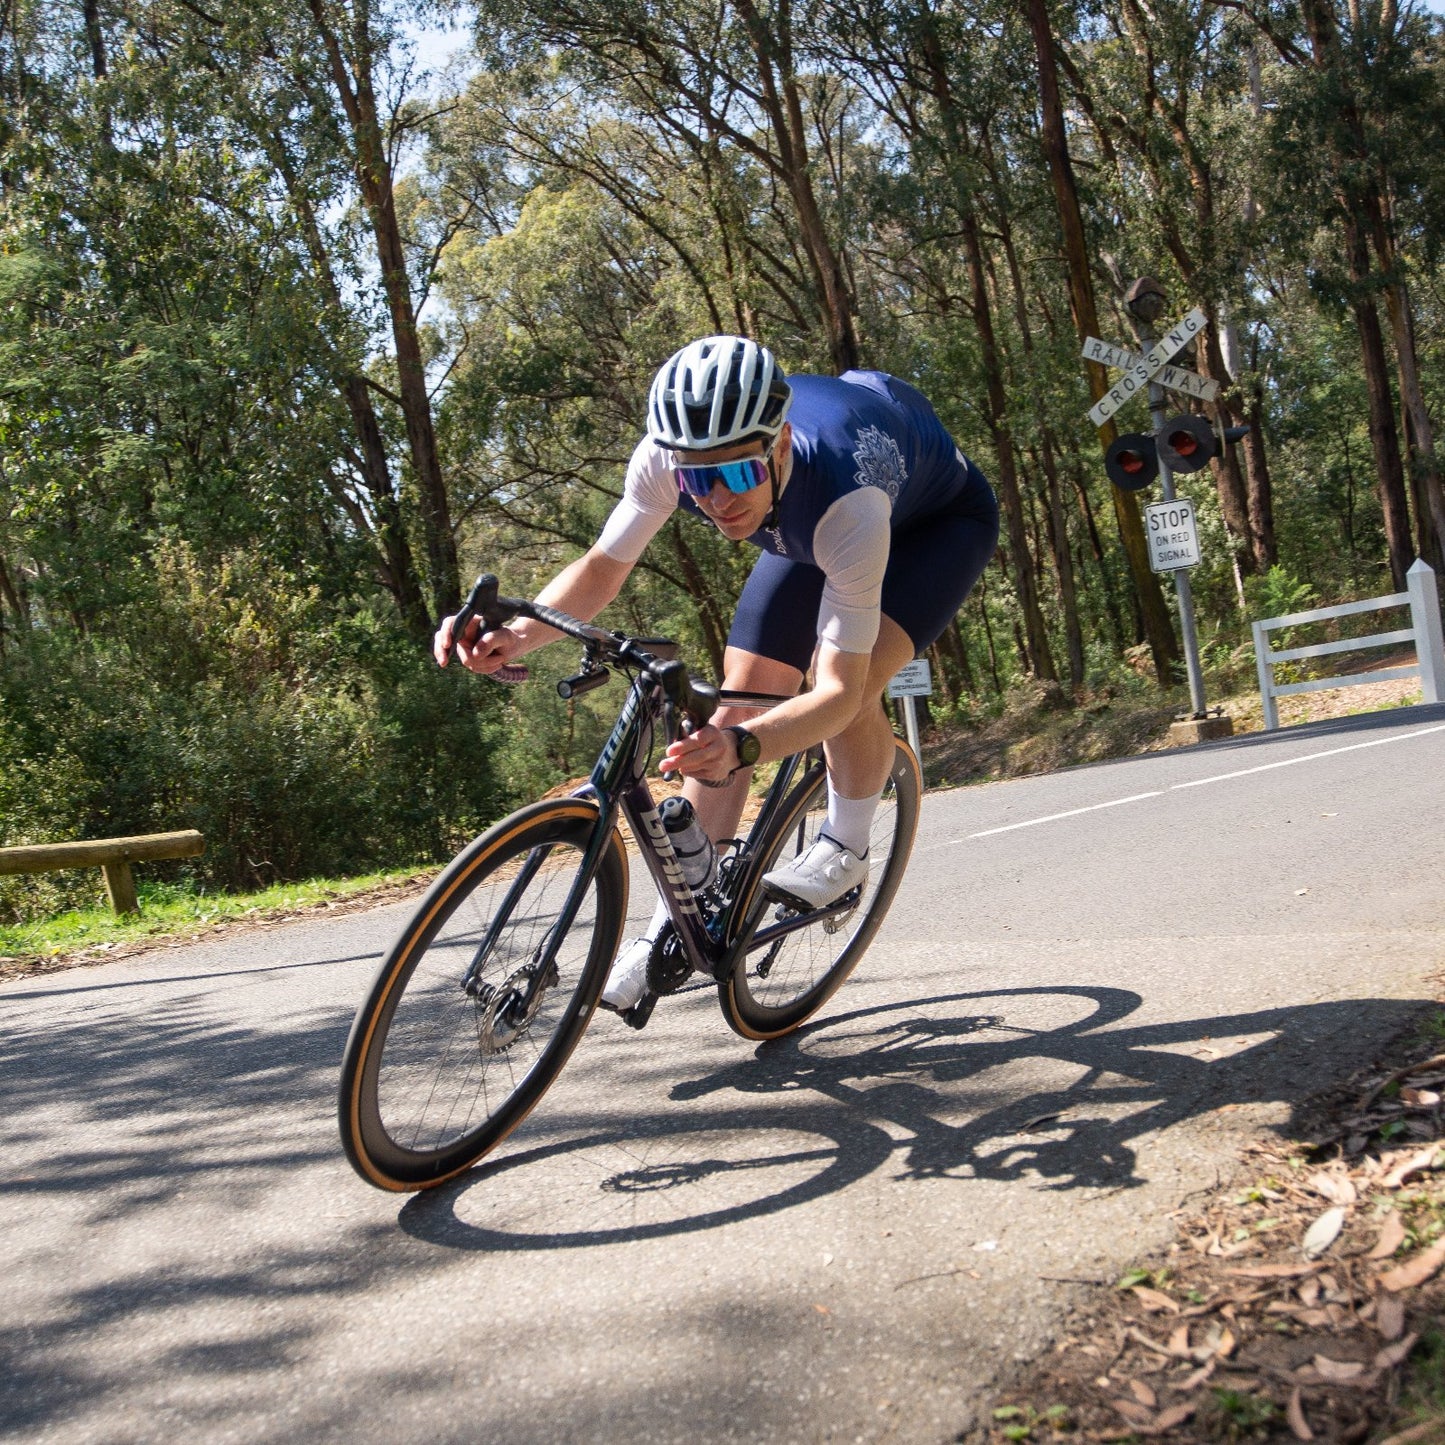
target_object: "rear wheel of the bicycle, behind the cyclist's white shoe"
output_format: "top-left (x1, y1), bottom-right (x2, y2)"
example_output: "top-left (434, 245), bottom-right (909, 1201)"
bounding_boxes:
top-left (718, 738), bottom-right (923, 1039)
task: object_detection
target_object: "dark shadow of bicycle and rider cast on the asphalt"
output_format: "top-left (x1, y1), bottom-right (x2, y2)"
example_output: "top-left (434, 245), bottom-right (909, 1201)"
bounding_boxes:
top-left (400, 985), bottom-right (1431, 1250)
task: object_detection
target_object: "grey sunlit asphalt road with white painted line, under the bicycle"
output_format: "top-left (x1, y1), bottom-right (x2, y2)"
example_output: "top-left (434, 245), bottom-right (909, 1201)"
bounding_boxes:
top-left (0, 708), bottom-right (1445, 1445)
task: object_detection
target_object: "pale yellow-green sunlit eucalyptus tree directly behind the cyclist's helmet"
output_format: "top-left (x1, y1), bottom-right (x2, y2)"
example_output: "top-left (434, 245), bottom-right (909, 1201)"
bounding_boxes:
top-left (431, 79), bottom-right (774, 682)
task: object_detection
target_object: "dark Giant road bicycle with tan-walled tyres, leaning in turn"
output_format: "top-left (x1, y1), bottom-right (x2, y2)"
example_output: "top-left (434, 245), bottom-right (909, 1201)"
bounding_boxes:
top-left (340, 574), bottom-right (922, 1191)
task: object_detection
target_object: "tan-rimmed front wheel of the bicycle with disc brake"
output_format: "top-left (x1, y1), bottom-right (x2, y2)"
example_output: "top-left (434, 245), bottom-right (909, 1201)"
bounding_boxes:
top-left (340, 798), bottom-right (627, 1189)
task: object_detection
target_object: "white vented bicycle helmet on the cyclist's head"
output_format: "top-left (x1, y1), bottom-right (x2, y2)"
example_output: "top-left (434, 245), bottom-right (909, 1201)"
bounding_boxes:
top-left (647, 337), bottom-right (793, 451)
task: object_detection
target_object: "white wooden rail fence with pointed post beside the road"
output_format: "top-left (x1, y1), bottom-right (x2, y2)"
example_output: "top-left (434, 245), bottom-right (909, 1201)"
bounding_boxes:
top-left (1254, 558), bottom-right (1445, 730)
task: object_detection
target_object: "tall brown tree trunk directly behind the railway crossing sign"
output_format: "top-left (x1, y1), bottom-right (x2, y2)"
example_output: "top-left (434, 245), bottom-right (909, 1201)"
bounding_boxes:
top-left (1027, 0), bottom-right (1181, 685)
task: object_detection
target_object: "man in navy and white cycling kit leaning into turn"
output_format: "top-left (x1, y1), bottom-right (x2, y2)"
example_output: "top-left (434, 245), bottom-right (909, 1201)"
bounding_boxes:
top-left (435, 335), bottom-right (998, 1010)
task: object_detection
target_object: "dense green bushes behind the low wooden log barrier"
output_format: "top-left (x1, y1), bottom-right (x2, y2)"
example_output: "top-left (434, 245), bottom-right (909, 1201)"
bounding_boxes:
top-left (0, 549), bottom-right (510, 919)
